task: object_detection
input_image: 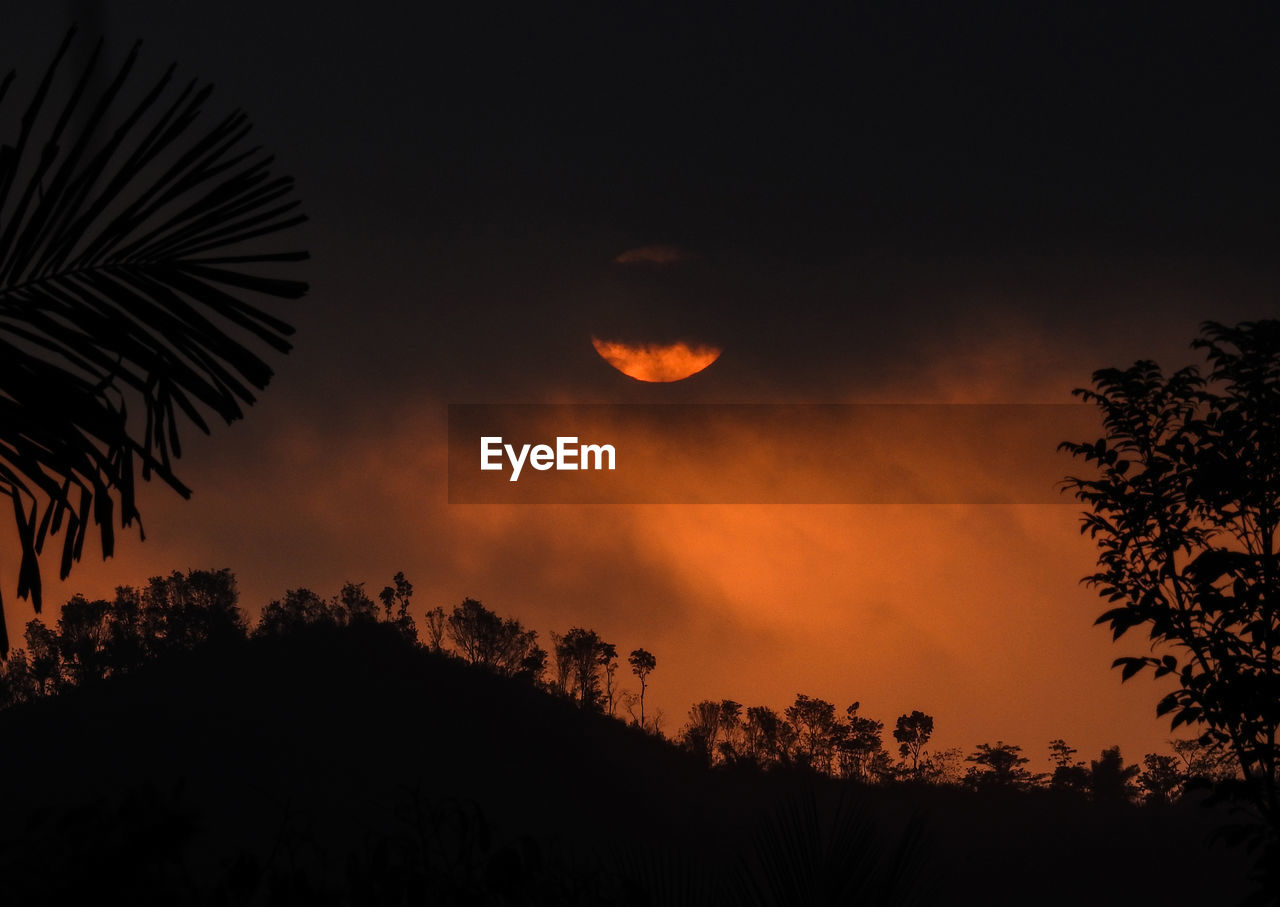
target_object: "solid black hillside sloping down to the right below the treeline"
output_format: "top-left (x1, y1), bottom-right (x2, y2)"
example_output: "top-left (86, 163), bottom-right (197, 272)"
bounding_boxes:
top-left (0, 626), bottom-right (1248, 904)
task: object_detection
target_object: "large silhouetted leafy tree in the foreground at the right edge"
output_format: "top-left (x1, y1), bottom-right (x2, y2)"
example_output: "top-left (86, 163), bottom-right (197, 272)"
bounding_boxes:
top-left (1061, 321), bottom-right (1280, 864)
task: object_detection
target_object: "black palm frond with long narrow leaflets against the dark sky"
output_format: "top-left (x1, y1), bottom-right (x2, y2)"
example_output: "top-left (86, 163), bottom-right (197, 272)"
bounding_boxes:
top-left (0, 29), bottom-right (307, 655)
